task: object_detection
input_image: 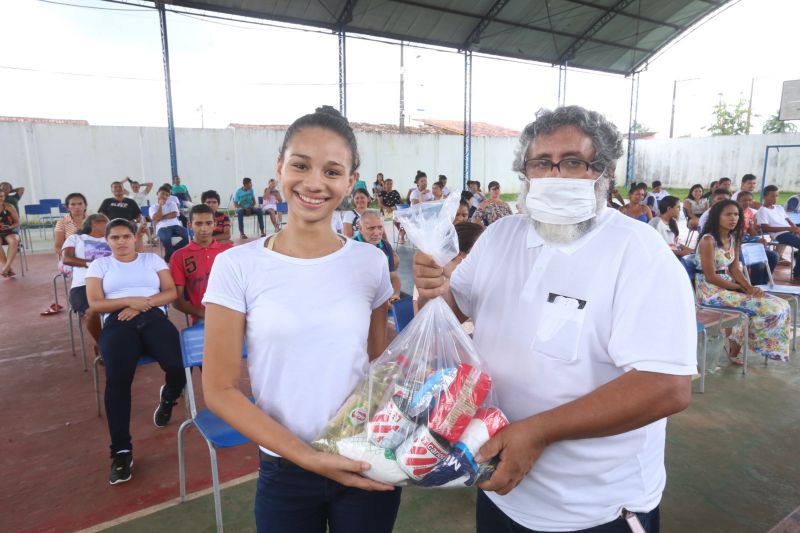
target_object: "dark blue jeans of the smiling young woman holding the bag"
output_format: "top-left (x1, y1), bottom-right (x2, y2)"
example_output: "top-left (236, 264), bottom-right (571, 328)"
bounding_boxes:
top-left (255, 452), bottom-right (401, 533)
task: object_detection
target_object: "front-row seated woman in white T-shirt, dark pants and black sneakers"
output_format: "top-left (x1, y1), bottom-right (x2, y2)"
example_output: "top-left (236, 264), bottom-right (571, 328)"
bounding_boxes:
top-left (86, 218), bottom-right (186, 485)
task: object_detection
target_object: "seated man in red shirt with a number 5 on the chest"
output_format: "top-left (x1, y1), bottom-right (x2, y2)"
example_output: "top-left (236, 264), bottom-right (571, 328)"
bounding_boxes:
top-left (169, 204), bottom-right (233, 324)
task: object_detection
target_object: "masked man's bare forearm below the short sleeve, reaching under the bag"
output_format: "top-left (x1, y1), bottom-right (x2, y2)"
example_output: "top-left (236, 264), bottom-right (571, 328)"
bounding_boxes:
top-left (526, 370), bottom-right (692, 444)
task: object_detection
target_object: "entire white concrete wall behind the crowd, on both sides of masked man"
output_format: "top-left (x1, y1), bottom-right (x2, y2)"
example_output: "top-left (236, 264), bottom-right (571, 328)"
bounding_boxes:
top-left (6, 123), bottom-right (800, 210)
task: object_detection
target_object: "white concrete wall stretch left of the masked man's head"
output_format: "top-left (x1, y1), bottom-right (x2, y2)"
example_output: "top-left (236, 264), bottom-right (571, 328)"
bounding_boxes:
top-left (0, 123), bottom-right (518, 210)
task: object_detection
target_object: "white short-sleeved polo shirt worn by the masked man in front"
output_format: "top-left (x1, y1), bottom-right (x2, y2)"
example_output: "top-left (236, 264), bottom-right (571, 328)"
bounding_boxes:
top-left (450, 209), bottom-right (697, 531)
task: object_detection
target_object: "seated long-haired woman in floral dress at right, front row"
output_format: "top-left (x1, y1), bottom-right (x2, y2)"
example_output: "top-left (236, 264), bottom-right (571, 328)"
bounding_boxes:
top-left (695, 200), bottom-right (790, 364)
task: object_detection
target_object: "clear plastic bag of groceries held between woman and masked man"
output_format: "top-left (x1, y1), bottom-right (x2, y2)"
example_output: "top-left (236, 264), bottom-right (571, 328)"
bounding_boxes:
top-left (313, 196), bottom-right (508, 488)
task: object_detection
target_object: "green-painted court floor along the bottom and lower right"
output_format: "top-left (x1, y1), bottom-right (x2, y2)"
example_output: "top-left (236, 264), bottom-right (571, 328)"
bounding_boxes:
top-left (100, 247), bottom-right (800, 533)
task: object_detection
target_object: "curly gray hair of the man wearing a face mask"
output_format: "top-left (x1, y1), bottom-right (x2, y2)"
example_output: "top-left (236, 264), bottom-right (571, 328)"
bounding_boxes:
top-left (512, 105), bottom-right (622, 174)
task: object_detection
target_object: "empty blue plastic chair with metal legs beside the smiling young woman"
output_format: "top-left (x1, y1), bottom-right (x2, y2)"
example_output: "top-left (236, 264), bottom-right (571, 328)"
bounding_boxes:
top-left (178, 324), bottom-right (250, 533)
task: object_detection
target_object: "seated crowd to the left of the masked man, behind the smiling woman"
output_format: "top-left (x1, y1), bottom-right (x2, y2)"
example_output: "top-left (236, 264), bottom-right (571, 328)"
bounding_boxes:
top-left (26, 160), bottom-right (494, 484)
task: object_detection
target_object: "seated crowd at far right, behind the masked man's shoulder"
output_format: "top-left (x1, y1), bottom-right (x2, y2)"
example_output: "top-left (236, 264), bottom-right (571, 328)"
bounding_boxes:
top-left (608, 174), bottom-right (800, 365)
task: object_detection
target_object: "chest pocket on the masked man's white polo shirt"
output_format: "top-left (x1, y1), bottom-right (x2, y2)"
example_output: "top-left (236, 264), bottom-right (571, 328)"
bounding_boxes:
top-left (531, 296), bottom-right (586, 363)
